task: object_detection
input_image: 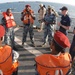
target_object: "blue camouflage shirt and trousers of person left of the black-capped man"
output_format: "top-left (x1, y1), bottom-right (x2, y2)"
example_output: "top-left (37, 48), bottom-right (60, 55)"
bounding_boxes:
top-left (44, 13), bottom-right (56, 44)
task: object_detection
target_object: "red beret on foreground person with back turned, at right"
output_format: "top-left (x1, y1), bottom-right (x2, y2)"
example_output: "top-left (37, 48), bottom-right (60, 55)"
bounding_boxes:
top-left (54, 31), bottom-right (70, 48)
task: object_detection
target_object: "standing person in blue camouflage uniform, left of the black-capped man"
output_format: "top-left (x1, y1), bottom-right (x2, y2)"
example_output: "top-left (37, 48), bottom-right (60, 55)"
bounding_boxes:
top-left (42, 6), bottom-right (56, 46)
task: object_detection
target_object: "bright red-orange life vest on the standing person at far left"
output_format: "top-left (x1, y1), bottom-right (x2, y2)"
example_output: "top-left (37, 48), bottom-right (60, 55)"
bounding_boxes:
top-left (2, 12), bottom-right (16, 28)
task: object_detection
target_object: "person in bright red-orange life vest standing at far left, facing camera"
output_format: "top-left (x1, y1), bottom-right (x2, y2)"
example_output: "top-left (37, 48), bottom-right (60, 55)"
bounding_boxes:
top-left (1, 9), bottom-right (17, 50)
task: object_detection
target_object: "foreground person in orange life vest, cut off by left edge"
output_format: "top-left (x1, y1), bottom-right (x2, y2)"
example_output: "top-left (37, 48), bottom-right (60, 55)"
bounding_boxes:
top-left (0, 25), bottom-right (19, 75)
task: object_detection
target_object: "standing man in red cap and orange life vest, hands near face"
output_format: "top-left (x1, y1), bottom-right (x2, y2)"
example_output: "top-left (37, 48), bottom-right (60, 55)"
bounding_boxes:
top-left (21, 4), bottom-right (35, 46)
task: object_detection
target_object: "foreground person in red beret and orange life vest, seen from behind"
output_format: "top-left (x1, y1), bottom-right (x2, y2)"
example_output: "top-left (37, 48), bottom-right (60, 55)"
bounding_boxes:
top-left (35, 31), bottom-right (71, 75)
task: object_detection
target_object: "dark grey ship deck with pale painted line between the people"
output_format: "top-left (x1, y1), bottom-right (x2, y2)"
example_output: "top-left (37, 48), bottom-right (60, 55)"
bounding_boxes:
top-left (15, 27), bottom-right (73, 75)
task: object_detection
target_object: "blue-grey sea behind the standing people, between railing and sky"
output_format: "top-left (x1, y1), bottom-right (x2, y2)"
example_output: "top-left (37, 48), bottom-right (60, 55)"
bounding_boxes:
top-left (0, 1), bottom-right (75, 18)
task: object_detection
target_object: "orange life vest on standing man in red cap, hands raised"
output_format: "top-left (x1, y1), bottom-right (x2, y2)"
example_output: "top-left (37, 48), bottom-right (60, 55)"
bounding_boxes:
top-left (23, 9), bottom-right (34, 24)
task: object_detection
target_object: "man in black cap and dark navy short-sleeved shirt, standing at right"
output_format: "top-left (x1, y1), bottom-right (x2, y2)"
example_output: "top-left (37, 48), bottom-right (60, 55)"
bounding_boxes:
top-left (58, 6), bottom-right (71, 35)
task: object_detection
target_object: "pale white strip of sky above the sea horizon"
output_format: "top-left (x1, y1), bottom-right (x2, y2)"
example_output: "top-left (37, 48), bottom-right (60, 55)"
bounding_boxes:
top-left (0, 0), bottom-right (75, 6)
